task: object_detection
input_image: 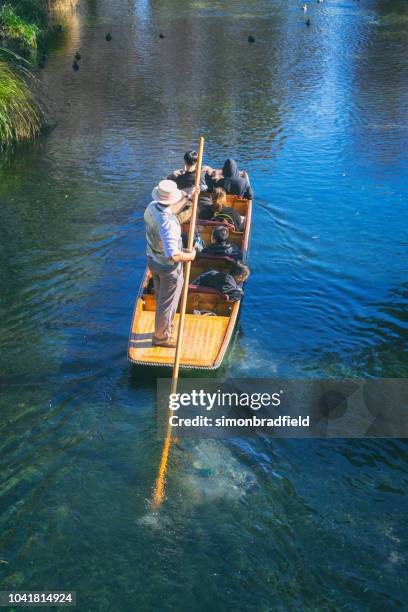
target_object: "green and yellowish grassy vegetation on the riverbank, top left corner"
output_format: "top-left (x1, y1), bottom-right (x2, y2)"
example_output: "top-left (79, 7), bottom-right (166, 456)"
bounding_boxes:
top-left (0, 0), bottom-right (77, 147)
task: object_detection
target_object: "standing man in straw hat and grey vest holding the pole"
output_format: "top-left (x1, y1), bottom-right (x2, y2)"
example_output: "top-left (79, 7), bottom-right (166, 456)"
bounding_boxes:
top-left (144, 180), bottom-right (196, 348)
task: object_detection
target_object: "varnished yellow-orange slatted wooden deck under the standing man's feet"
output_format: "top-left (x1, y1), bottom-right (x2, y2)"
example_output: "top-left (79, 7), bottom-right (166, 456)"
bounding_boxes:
top-left (129, 310), bottom-right (230, 368)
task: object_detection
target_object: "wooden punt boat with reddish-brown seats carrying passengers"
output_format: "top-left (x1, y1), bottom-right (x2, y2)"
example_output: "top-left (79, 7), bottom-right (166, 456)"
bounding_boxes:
top-left (128, 196), bottom-right (252, 370)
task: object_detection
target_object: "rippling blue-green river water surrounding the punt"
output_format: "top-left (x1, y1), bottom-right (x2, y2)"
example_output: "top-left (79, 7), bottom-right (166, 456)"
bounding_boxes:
top-left (0, 0), bottom-right (408, 611)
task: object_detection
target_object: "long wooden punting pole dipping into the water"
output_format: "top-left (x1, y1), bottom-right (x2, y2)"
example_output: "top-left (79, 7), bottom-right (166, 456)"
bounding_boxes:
top-left (152, 136), bottom-right (204, 510)
